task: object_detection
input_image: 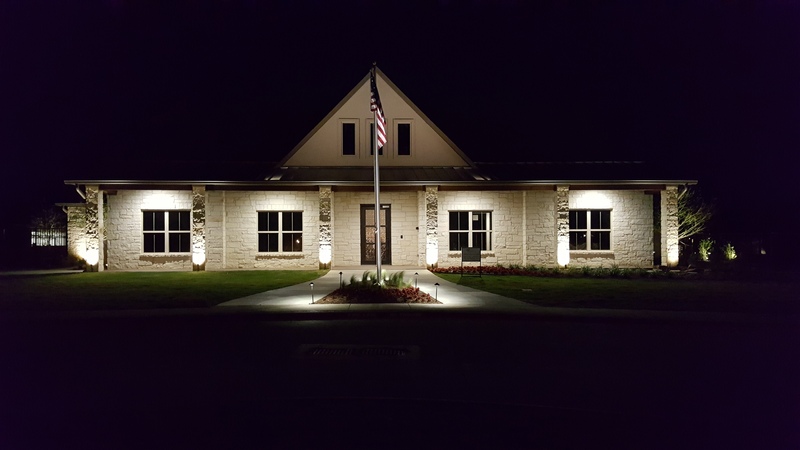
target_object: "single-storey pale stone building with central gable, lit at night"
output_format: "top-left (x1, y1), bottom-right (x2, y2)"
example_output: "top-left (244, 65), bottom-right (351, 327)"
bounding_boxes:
top-left (62, 70), bottom-right (694, 270)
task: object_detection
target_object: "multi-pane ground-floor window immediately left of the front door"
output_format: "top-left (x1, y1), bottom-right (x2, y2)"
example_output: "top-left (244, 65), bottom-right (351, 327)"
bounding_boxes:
top-left (258, 211), bottom-right (303, 252)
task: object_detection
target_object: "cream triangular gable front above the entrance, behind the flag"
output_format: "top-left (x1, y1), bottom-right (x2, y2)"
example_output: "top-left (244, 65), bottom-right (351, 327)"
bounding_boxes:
top-left (275, 68), bottom-right (475, 175)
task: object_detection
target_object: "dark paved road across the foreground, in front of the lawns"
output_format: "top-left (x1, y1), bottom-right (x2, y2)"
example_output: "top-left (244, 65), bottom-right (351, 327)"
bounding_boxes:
top-left (0, 308), bottom-right (800, 449)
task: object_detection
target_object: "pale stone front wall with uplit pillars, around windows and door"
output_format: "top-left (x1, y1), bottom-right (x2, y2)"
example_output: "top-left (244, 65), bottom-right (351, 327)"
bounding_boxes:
top-left (68, 185), bottom-right (677, 270)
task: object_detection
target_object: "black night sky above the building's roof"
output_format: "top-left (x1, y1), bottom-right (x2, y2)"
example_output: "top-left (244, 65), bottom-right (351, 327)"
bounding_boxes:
top-left (0, 0), bottom-right (800, 236)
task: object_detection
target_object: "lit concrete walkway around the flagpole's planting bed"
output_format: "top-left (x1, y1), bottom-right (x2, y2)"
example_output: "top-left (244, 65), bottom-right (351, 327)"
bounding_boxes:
top-left (218, 267), bottom-right (541, 313)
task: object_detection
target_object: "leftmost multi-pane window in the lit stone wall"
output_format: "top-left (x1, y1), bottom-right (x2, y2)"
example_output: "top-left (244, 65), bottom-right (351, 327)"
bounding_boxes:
top-left (142, 211), bottom-right (192, 253)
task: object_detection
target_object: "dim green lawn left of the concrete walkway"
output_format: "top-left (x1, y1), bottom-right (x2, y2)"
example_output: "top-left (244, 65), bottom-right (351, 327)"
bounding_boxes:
top-left (0, 270), bottom-right (327, 311)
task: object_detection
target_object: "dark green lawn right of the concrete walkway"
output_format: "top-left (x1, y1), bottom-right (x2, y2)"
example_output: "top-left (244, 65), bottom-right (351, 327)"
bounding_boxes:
top-left (436, 274), bottom-right (800, 314)
